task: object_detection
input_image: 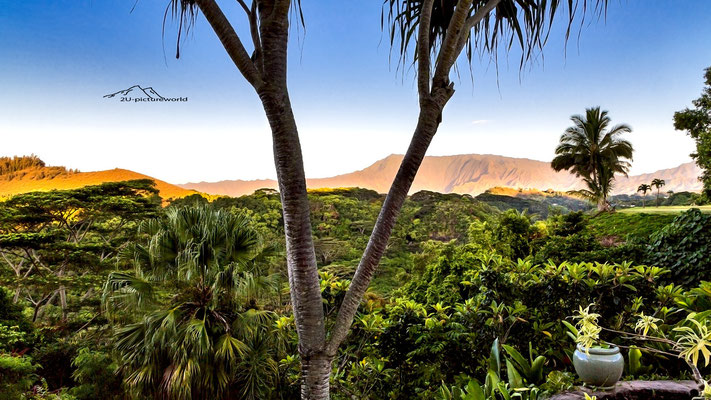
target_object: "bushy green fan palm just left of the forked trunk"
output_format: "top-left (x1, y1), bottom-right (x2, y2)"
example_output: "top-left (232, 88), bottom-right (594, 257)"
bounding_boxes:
top-left (103, 207), bottom-right (295, 399)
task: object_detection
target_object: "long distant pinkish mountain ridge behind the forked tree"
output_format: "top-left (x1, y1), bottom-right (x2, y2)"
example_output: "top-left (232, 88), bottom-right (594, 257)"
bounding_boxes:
top-left (178, 154), bottom-right (701, 196)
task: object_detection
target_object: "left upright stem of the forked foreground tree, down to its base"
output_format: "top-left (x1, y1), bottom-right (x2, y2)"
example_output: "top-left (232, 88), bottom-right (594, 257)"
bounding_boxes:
top-left (257, 1), bottom-right (331, 399)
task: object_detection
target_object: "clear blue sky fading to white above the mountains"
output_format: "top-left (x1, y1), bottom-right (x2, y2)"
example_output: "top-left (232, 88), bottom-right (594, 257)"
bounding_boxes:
top-left (0, 0), bottom-right (711, 183)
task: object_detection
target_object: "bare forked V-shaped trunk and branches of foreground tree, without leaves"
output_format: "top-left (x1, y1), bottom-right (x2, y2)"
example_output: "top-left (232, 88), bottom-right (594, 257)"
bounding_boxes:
top-left (196, 0), bottom-right (478, 400)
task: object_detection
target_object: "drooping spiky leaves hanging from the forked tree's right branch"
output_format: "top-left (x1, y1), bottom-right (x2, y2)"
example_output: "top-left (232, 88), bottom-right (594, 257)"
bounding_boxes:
top-left (381, 0), bottom-right (607, 71)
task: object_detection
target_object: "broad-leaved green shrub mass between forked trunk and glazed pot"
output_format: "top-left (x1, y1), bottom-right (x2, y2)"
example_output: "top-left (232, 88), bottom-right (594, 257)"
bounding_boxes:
top-left (370, 247), bottom-right (661, 398)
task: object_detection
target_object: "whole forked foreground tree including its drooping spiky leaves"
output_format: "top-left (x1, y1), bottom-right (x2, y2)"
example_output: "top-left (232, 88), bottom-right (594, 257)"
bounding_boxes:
top-left (157, 0), bottom-right (607, 399)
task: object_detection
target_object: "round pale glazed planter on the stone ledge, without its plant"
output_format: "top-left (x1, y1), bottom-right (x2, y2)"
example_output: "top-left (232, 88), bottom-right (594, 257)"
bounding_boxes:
top-left (573, 345), bottom-right (625, 388)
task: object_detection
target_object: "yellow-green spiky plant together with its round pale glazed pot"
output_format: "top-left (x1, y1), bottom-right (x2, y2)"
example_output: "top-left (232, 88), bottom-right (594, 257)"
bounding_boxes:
top-left (563, 306), bottom-right (625, 388)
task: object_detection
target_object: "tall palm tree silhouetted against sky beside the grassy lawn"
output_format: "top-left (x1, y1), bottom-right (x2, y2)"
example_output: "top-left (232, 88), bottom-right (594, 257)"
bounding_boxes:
top-left (551, 107), bottom-right (634, 211)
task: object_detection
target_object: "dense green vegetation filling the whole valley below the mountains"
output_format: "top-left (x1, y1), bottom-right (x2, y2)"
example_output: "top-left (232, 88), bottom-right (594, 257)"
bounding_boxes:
top-left (0, 181), bottom-right (711, 400)
